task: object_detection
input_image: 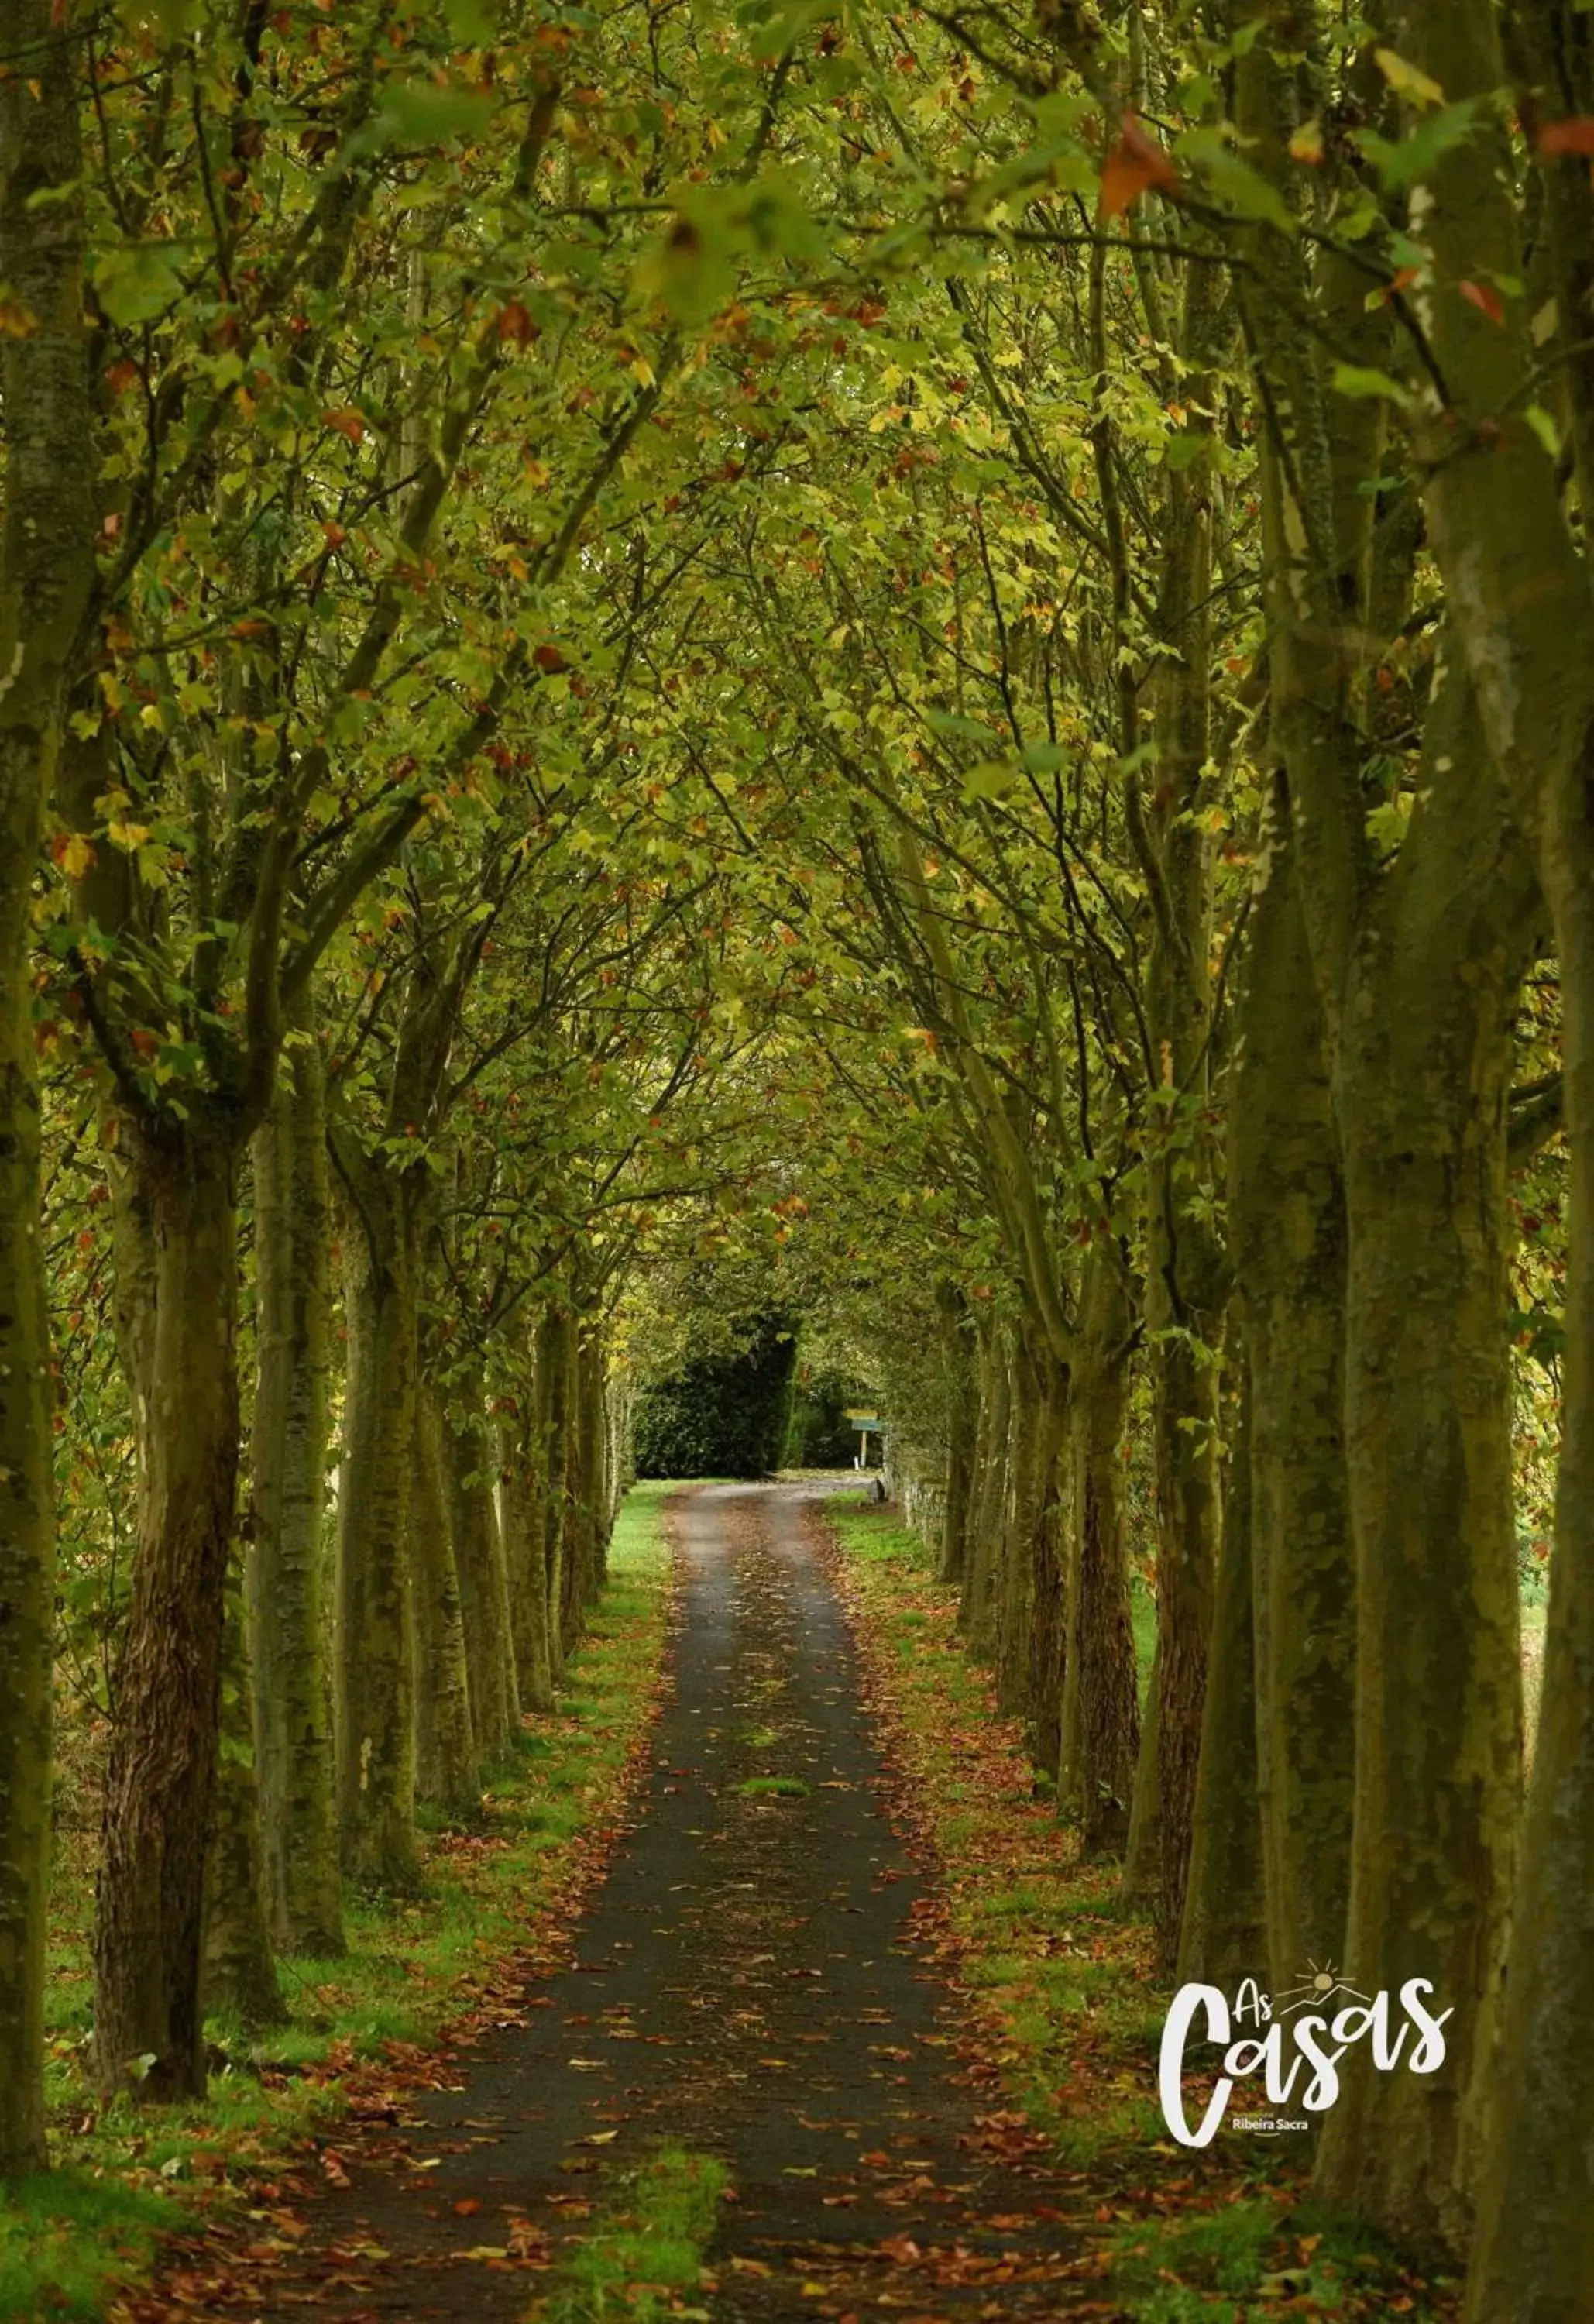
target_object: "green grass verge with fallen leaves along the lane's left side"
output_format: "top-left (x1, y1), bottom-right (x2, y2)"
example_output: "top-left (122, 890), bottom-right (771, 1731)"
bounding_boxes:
top-left (0, 1483), bottom-right (674, 2319)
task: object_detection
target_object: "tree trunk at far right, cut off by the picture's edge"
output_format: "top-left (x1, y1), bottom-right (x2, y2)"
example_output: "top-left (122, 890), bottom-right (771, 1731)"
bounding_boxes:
top-left (1399, 0), bottom-right (1594, 2296)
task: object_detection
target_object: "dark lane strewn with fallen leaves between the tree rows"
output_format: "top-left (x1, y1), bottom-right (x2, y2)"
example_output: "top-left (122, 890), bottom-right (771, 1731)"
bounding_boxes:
top-left (186, 1485), bottom-right (1097, 2324)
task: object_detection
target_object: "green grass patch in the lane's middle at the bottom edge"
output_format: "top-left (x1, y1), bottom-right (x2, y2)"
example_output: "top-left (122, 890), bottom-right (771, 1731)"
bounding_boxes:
top-left (532, 2147), bottom-right (730, 2324)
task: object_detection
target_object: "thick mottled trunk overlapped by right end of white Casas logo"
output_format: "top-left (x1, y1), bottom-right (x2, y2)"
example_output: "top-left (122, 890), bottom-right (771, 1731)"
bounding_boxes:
top-left (1317, 867), bottom-right (1522, 2250)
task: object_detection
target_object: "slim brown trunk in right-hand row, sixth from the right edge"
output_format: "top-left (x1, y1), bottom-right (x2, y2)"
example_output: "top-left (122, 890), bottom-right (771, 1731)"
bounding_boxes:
top-left (1057, 1255), bottom-right (1141, 1855)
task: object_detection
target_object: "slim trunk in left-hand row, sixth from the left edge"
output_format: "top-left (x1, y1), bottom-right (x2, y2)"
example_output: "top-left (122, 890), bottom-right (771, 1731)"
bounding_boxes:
top-left (409, 1380), bottom-right (481, 1815)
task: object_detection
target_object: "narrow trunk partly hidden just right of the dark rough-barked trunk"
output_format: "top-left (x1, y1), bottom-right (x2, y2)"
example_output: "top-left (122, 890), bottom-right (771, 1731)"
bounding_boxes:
top-left (202, 1583), bottom-right (288, 2029)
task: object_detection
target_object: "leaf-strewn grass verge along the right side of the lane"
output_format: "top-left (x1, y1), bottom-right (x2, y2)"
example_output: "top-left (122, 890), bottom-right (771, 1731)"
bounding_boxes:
top-left (827, 1494), bottom-right (1457, 2324)
